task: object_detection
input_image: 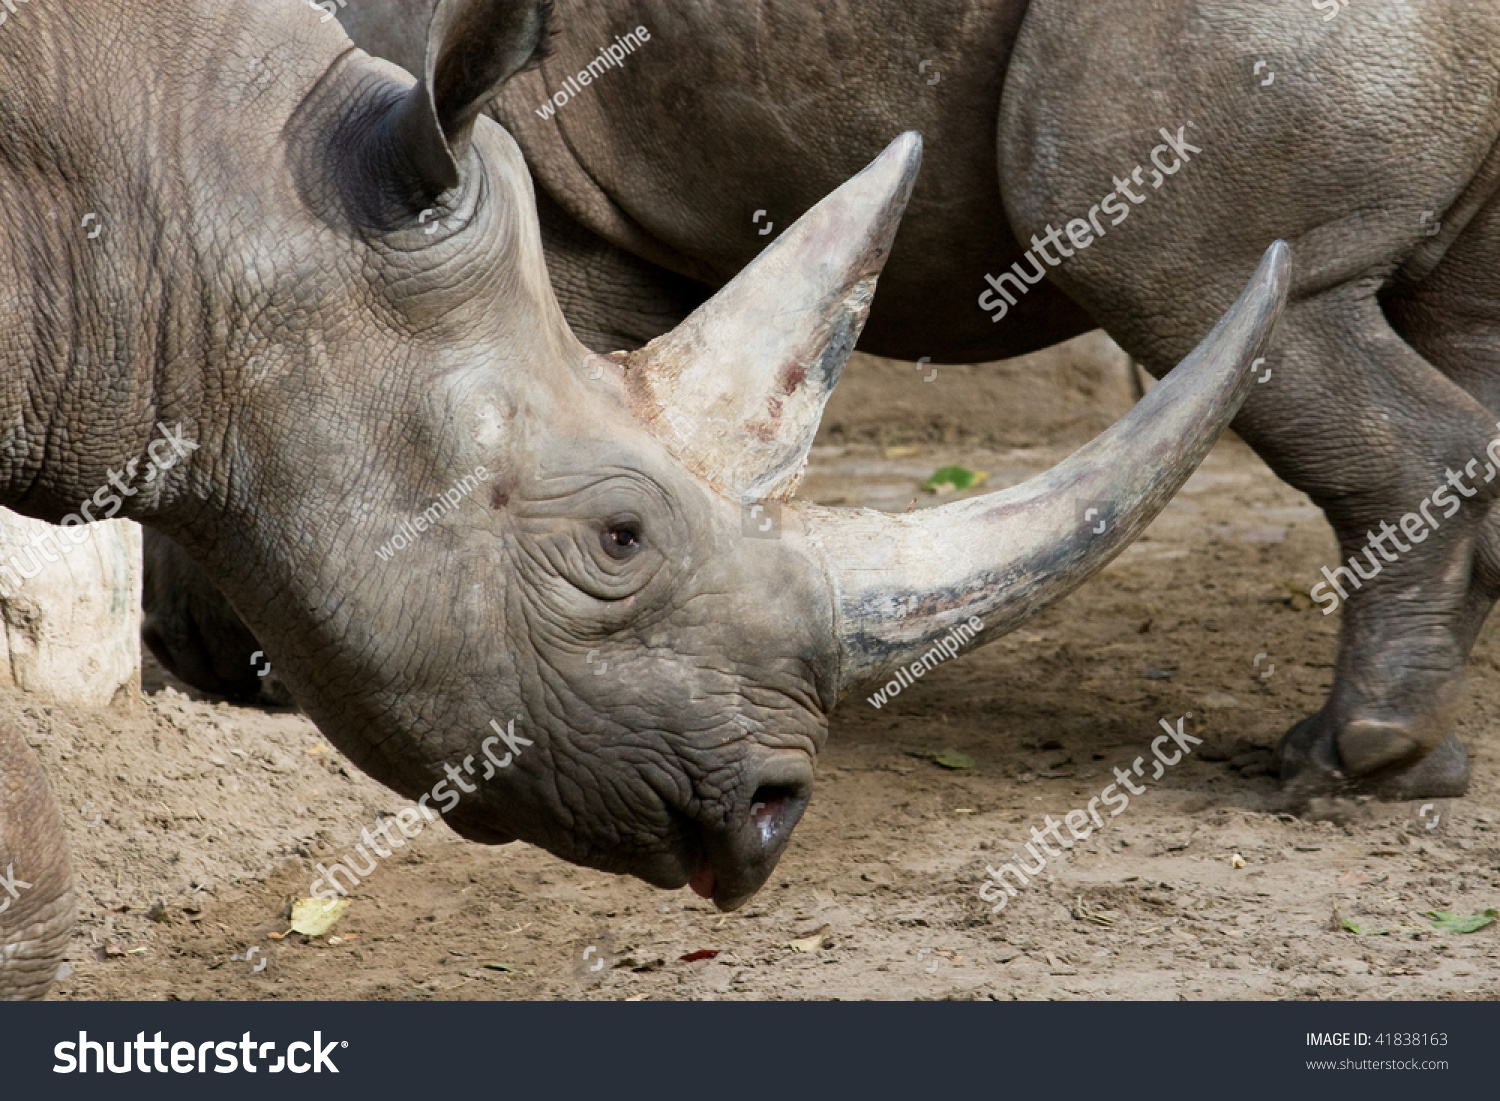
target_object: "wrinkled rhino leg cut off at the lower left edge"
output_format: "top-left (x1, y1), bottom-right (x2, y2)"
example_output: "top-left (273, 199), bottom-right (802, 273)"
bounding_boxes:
top-left (0, 726), bottom-right (74, 1002)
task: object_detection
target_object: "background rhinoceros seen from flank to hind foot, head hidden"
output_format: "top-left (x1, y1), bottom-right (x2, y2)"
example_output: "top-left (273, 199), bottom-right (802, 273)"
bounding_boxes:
top-left (316, 0), bottom-right (1500, 798)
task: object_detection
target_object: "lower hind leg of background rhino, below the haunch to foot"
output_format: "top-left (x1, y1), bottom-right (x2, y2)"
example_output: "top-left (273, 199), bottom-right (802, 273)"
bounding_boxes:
top-left (1235, 291), bottom-right (1500, 800)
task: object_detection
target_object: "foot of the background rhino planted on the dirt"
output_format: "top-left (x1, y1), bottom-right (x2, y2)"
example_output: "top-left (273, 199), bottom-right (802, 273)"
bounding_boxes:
top-left (1272, 713), bottom-right (1470, 804)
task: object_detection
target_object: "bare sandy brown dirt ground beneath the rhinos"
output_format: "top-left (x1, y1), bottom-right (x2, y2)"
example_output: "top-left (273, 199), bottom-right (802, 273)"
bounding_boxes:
top-left (26, 335), bottom-right (1500, 1001)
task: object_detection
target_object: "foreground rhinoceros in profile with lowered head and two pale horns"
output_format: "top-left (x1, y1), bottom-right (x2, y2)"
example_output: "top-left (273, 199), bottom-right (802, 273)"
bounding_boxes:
top-left (0, 0), bottom-right (1290, 995)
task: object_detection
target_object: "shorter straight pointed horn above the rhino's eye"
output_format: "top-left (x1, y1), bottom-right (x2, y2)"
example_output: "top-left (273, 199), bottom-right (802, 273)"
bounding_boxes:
top-left (626, 132), bottom-right (923, 501)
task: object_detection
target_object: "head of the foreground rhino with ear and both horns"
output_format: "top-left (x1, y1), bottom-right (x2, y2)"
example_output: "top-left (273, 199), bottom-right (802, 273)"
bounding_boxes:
top-left (146, 0), bottom-right (1287, 908)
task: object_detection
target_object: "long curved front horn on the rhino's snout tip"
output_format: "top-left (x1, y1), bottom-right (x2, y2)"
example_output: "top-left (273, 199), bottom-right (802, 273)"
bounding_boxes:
top-left (804, 242), bottom-right (1292, 696)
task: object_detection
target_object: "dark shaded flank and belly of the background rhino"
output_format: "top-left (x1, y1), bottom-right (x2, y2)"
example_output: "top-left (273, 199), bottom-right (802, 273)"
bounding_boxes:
top-left (495, 0), bottom-right (1089, 359)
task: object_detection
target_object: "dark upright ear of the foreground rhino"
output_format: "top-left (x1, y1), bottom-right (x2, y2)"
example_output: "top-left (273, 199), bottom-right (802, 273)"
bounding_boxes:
top-left (389, 0), bottom-right (552, 204)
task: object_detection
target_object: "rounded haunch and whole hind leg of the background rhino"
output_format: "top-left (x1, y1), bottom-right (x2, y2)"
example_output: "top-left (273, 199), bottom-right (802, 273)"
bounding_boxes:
top-left (999, 0), bottom-right (1500, 801)
